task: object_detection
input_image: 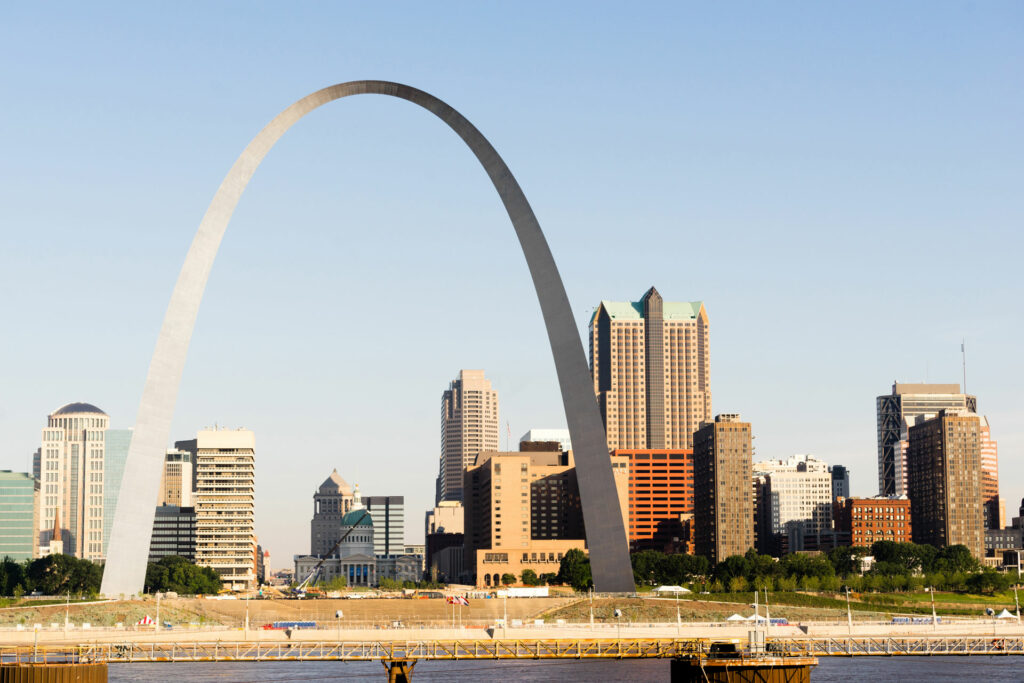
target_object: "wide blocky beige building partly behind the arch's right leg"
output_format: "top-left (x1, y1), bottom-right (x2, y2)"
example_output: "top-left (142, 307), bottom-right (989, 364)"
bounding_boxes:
top-left (464, 451), bottom-right (629, 588)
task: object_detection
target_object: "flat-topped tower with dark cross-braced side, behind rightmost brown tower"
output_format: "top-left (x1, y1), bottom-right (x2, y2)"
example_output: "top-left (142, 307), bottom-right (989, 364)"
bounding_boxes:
top-left (876, 382), bottom-right (978, 497)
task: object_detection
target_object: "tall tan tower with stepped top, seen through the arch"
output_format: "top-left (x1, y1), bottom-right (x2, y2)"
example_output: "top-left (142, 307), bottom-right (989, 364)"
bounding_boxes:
top-left (434, 370), bottom-right (498, 503)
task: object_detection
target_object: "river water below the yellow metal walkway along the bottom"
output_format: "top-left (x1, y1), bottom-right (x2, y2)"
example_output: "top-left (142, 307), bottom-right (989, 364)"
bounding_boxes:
top-left (110, 656), bottom-right (1024, 683)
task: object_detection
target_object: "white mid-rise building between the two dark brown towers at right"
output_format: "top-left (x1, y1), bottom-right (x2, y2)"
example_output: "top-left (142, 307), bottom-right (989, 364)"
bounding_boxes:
top-left (753, 455), bottom-right (834, 554)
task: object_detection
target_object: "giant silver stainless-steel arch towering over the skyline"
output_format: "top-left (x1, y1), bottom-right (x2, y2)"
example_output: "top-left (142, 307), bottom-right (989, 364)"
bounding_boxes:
top-left (101, 81), bottom-right (634, 596)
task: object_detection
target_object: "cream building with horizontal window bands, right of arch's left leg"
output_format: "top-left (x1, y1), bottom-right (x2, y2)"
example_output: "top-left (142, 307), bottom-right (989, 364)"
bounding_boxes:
top-left (174, 428), bottom-right (256, 589)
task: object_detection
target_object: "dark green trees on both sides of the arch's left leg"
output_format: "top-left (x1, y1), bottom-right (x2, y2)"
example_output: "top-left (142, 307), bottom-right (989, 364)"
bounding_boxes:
top-left (0, 554), bottom-right (221, 597)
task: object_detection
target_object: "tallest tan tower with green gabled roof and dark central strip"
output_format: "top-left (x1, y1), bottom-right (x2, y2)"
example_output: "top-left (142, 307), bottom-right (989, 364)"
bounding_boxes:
top-left (590, 287), bottom-right (711, 451)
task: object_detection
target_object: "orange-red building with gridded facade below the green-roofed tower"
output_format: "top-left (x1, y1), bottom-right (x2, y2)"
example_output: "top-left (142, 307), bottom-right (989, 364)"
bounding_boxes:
top-left (614, 449), bottom-right (693, 553)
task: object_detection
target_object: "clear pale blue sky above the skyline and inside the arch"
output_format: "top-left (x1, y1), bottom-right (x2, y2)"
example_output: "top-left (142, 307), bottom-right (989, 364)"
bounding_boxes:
top-left (0, 2), bottom-right (1024, 567)
